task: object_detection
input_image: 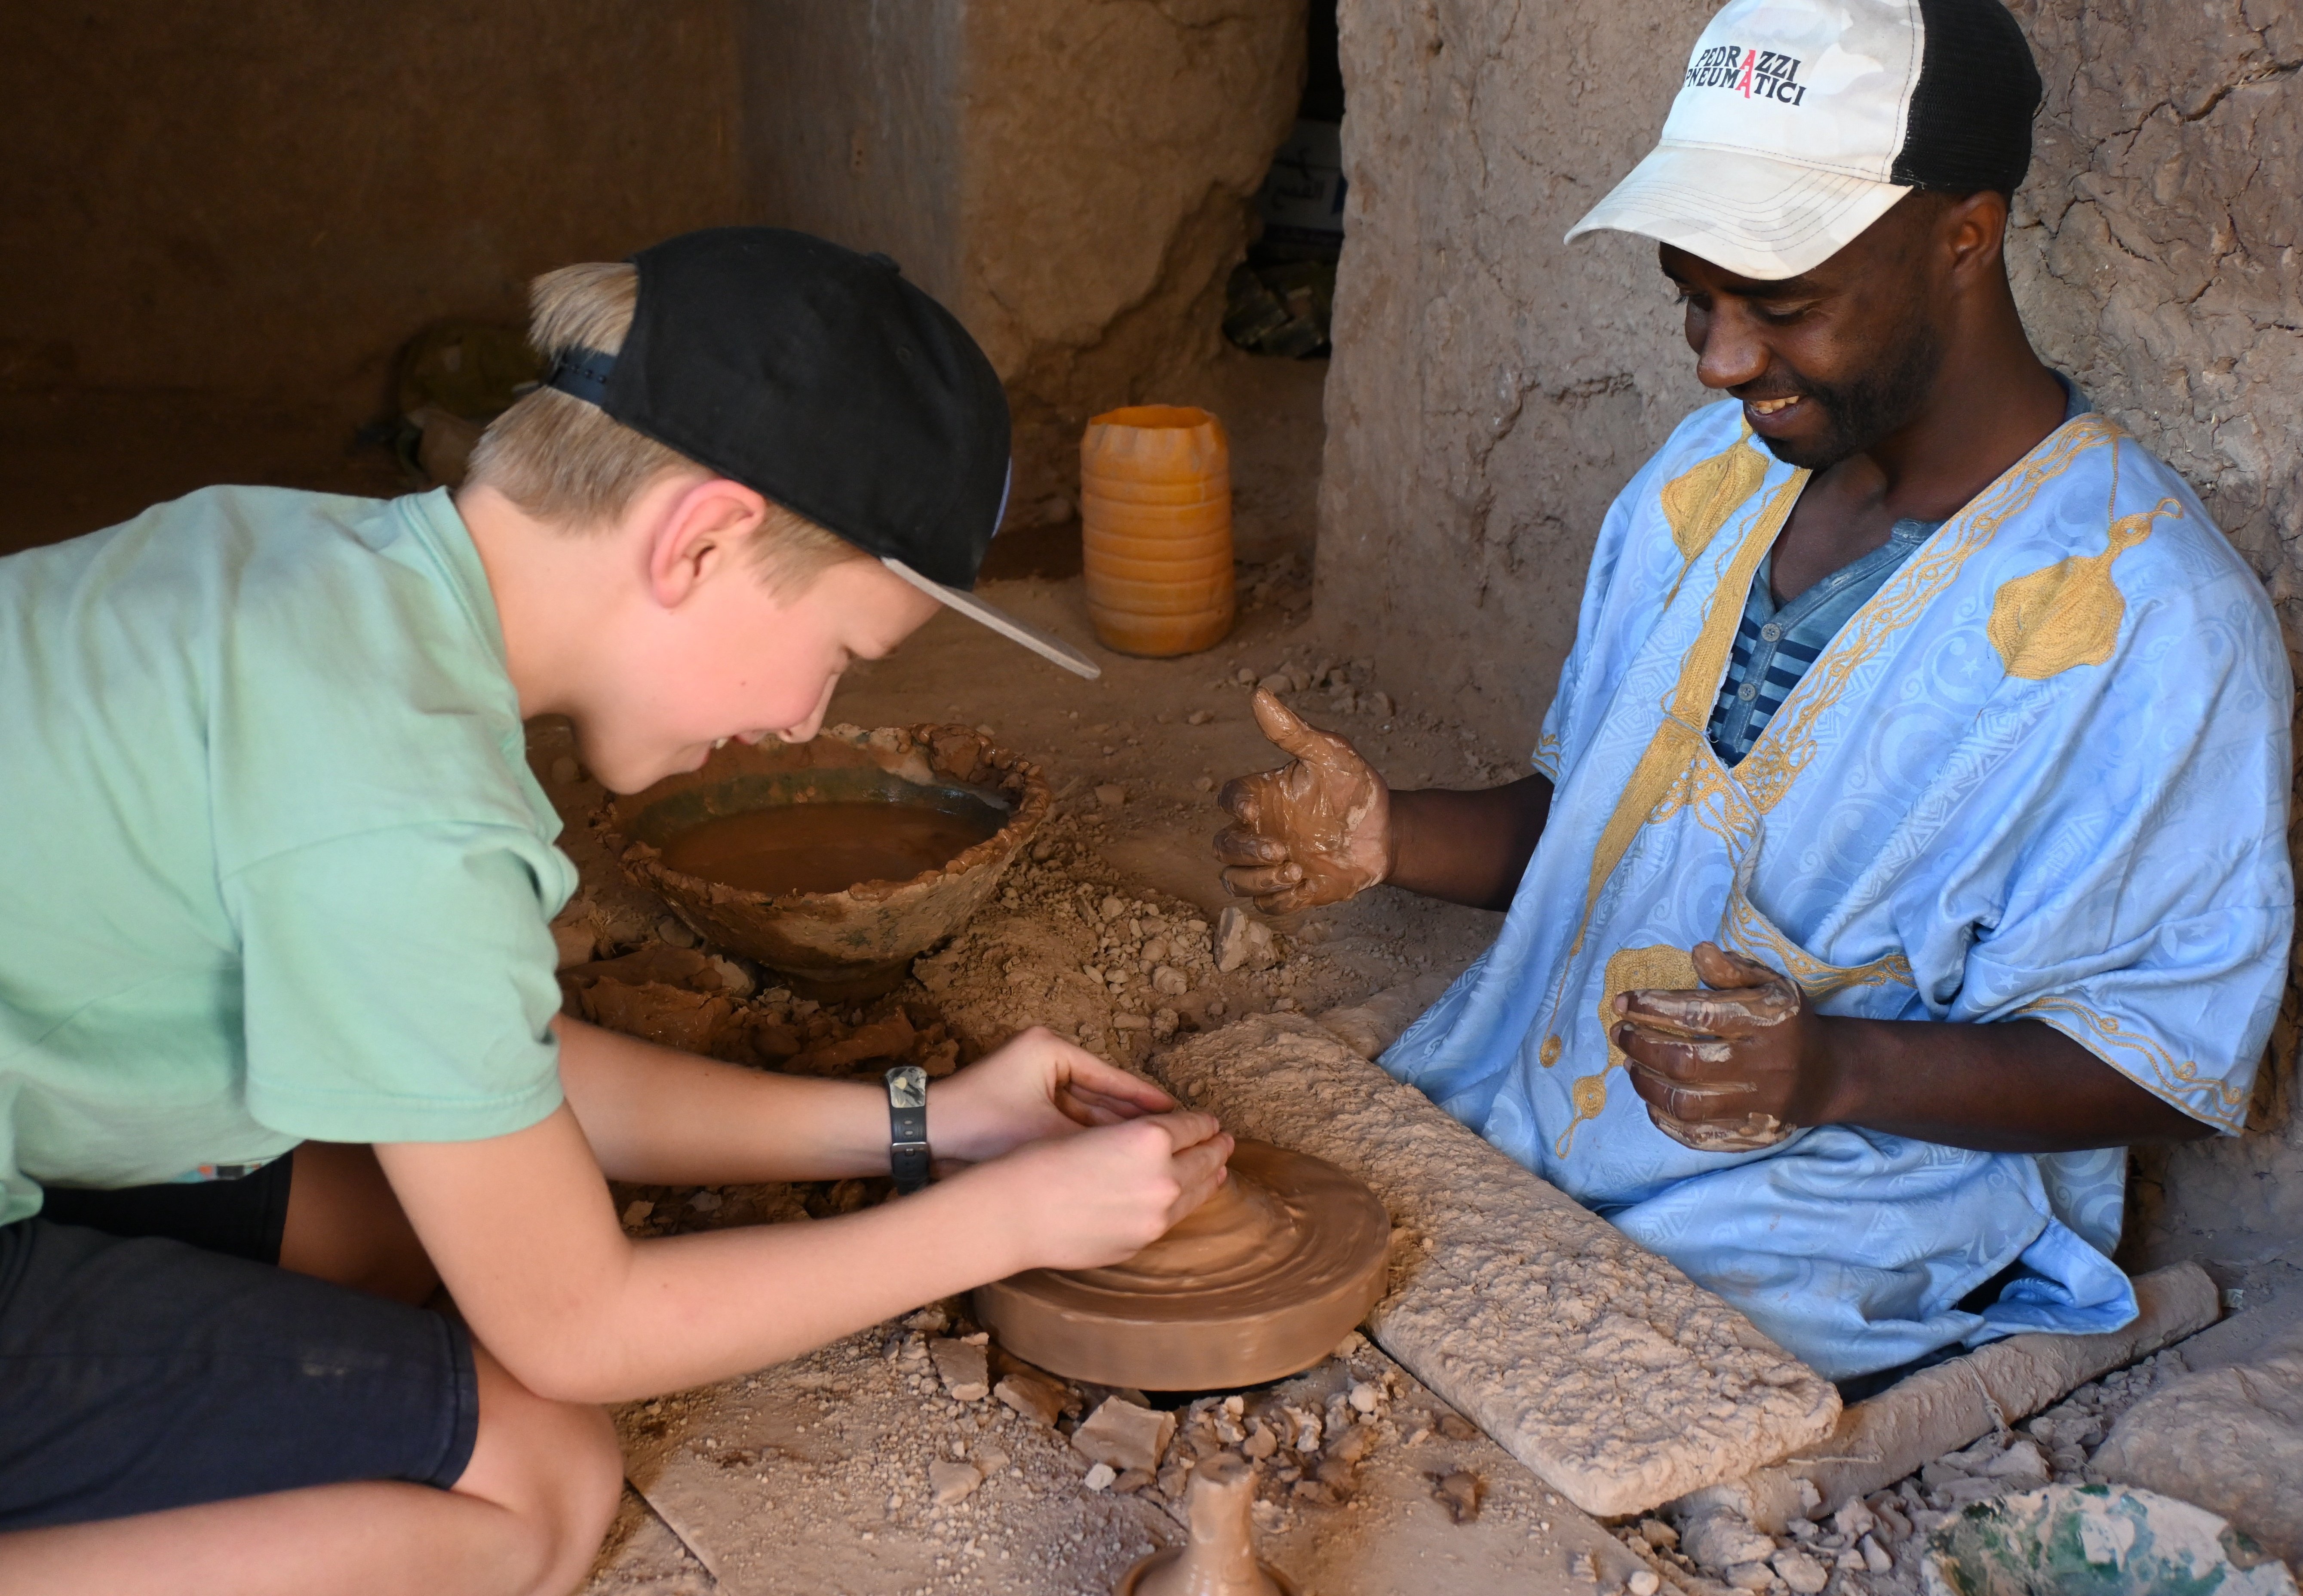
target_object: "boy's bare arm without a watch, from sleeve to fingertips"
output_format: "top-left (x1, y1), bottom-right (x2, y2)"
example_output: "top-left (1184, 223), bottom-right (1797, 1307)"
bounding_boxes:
top-left (375, 1101), bottom-right (1230, 1403)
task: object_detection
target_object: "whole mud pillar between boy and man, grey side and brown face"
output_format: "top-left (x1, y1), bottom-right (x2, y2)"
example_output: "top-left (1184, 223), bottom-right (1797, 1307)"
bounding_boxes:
top-left (746, 0), bottom-right (1303, 523)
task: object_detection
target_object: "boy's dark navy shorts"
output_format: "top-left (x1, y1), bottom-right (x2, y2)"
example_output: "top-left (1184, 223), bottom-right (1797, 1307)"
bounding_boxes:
top-left (0, 1158), bottom-right (479, 1532)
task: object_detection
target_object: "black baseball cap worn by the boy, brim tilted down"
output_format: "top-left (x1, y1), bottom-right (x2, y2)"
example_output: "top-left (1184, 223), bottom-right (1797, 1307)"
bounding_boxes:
top-left (546, 228), bottom-right (1103, 677)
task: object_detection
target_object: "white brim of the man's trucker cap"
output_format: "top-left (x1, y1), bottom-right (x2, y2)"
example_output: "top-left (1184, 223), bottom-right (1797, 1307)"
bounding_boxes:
top-left (1568, 145), bottom-right (1909, 281)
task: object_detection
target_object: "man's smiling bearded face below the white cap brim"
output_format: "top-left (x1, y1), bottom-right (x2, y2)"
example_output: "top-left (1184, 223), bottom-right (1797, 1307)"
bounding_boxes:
top-left (1661, 193), bottom-right (1953, 470)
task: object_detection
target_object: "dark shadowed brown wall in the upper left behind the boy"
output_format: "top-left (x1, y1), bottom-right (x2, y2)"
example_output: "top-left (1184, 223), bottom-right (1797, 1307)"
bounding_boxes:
top-left (0, 0), bottom-right (744, 433)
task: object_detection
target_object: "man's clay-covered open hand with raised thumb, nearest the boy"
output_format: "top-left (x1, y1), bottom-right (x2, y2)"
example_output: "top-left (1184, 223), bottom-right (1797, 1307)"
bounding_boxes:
top-left (1216, 691), bottom-right (1391, 914)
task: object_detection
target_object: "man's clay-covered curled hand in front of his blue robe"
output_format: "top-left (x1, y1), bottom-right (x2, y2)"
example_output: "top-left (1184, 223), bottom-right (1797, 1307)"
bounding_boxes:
top-left (1615, 942), bottom-right (1829, 1151)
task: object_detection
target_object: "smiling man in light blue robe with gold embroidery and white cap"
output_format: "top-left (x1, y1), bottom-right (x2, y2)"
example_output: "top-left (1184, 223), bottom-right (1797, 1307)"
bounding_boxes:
top-left (1218, 0), bottom-right (2294, 1391)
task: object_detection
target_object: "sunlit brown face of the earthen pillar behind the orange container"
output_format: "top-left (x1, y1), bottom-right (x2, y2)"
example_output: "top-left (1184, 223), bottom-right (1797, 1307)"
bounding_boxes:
top-left (958, 0), bottom-right (1303, 518)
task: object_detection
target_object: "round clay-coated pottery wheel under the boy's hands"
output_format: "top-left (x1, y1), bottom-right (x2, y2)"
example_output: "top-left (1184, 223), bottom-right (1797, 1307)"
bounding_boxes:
top-left (974, 1142), bottom-right (1391, 1391)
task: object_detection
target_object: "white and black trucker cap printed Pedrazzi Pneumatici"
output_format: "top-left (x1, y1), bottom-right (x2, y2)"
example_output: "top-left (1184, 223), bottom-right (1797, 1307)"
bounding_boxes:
top-left (1568, 0), bottom-right (2040, 281)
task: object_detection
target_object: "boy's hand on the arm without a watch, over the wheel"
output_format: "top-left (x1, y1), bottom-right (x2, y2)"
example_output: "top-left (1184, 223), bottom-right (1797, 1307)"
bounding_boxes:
top-left (942, 1110), bottom-right (1232, 1271)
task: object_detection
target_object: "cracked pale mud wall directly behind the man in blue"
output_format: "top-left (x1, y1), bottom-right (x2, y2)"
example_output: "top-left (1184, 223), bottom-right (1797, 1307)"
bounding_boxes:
top-left (1315, 0), bottom-right (2303, 1267)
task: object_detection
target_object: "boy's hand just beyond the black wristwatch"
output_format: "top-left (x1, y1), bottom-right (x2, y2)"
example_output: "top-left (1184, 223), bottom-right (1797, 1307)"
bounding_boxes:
top-left (928, 1025), bottom-right (1175, 1163)
